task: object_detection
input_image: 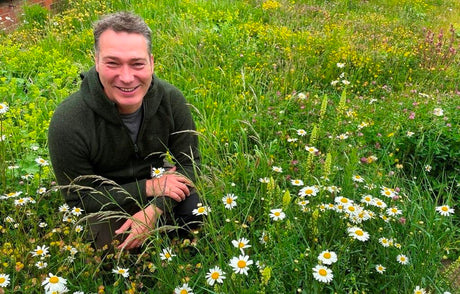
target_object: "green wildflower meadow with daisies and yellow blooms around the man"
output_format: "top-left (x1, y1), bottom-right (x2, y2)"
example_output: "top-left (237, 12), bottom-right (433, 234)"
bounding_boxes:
top-left (0, 0), bottom-right (460, 293)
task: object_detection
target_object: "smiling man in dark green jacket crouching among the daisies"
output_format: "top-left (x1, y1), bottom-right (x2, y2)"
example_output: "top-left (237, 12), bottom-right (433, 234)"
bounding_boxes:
top-left (48, 12), bottom-right (200, 249)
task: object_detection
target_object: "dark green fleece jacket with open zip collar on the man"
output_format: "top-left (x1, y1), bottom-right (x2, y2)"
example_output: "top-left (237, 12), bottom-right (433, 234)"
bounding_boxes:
top-left (48, 67), bottom-right (200, 213)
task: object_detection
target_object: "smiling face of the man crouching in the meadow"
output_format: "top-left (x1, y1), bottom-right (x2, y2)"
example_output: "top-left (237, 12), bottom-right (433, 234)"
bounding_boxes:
top-left (95, 30), bottom-right (153, 114)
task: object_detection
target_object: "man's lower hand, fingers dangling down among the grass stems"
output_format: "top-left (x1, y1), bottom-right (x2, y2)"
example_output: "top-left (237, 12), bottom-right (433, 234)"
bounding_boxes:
top-left (115, 205), bottom-right (163, 250)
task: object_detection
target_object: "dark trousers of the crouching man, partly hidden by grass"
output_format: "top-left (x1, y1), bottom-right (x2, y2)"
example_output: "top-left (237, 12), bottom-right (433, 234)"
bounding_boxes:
top-left (87, 193), bottom-right (202, 253)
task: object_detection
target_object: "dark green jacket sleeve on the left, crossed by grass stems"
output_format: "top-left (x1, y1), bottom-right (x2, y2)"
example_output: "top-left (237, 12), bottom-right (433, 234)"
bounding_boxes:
top-left (48, 103), bottom-right (147, 213)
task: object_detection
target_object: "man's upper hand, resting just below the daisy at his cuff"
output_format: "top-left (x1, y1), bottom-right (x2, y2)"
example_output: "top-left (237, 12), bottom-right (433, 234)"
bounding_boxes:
top-left (145, 167), bottom-right (193, 202)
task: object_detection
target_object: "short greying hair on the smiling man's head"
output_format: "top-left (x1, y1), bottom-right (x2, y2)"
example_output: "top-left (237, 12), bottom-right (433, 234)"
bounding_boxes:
top-left (93, 11), bottom-right (152, 54)
